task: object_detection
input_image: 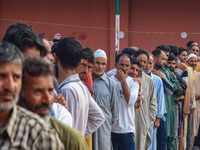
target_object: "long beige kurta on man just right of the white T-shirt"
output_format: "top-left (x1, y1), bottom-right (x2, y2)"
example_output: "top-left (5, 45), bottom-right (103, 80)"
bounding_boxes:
top-left (135, 73), bottom-right (157, 150)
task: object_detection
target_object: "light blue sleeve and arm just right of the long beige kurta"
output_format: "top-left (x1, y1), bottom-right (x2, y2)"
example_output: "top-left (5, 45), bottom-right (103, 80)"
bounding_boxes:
top-left (150, 73), bottom-right (167, 121)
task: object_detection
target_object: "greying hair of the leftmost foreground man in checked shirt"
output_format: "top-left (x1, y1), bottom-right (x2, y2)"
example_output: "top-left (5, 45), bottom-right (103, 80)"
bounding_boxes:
top-left (0, 41), bottom-right (24, 63)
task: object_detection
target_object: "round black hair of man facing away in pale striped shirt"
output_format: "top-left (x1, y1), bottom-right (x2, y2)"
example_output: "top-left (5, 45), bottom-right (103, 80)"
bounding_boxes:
top-left (56, 37), bottom-right (83, 69)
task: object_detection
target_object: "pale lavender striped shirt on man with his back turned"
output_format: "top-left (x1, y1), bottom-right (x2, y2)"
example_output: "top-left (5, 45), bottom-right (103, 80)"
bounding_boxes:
top-left (59, 74), bottom-right (105, 137)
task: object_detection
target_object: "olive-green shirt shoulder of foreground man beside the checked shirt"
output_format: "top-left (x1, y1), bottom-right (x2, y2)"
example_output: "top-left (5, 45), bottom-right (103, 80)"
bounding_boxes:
top-left (49, 117), bottom-right (87, 149)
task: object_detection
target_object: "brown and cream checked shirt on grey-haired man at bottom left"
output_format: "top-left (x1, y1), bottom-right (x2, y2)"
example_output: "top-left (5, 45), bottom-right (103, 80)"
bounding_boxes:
top-left (0, 106), bottom-right (64, 150)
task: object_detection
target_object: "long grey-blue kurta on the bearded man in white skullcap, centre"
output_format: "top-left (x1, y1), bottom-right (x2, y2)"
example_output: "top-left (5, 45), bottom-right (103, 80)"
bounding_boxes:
top-left (92, 73), bottom-right (120, 150)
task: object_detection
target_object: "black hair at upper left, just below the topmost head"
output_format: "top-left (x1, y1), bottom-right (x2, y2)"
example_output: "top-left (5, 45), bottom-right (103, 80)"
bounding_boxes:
top-left (5, 29), bottom-right (46, 56)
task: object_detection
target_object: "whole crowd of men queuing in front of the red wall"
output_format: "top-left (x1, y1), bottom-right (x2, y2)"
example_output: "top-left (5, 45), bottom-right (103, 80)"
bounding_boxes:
top-left (0, 22), bottom-right (200, 150)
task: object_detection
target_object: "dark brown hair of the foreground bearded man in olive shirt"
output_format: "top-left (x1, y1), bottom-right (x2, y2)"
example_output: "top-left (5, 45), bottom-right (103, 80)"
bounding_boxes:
top-left (22, 56), bottom-right (54, 85)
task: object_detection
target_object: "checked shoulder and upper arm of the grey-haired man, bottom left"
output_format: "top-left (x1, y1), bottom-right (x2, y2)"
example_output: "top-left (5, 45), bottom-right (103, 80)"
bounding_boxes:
top-left (7, 106), bottom-right (63, 149)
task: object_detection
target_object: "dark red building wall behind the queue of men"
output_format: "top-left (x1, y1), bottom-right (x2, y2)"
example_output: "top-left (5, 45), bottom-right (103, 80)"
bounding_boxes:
top-left (0, 0), bottom-right (200, 70)
